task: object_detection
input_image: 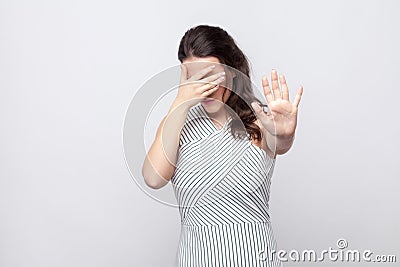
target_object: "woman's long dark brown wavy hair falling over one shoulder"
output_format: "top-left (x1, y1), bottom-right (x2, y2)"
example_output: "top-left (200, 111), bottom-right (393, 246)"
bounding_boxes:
top-left (178, 25), bottom-right (261, 141)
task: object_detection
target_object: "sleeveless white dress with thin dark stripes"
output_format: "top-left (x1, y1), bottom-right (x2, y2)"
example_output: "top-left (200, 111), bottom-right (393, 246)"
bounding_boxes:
top-left (171, 103), bottom-right (282, 267)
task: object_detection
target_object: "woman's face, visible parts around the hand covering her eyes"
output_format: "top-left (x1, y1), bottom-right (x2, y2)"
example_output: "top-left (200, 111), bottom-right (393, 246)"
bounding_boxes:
top-left (183, 57), bottom-right (231, 113)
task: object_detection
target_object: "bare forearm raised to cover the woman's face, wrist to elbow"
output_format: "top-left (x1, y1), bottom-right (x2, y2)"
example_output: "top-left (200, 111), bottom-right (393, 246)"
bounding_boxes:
top-left (142, 100), bottom-right (189, 189)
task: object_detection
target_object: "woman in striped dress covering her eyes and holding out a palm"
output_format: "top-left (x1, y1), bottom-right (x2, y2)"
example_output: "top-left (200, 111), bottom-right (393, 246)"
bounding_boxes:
top-left (142, 25), bottom-right (303, 267)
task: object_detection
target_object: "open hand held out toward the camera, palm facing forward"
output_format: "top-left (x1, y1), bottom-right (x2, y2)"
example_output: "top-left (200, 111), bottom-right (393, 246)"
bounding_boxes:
top-left (252, 70), bottom-right (303, 137)
